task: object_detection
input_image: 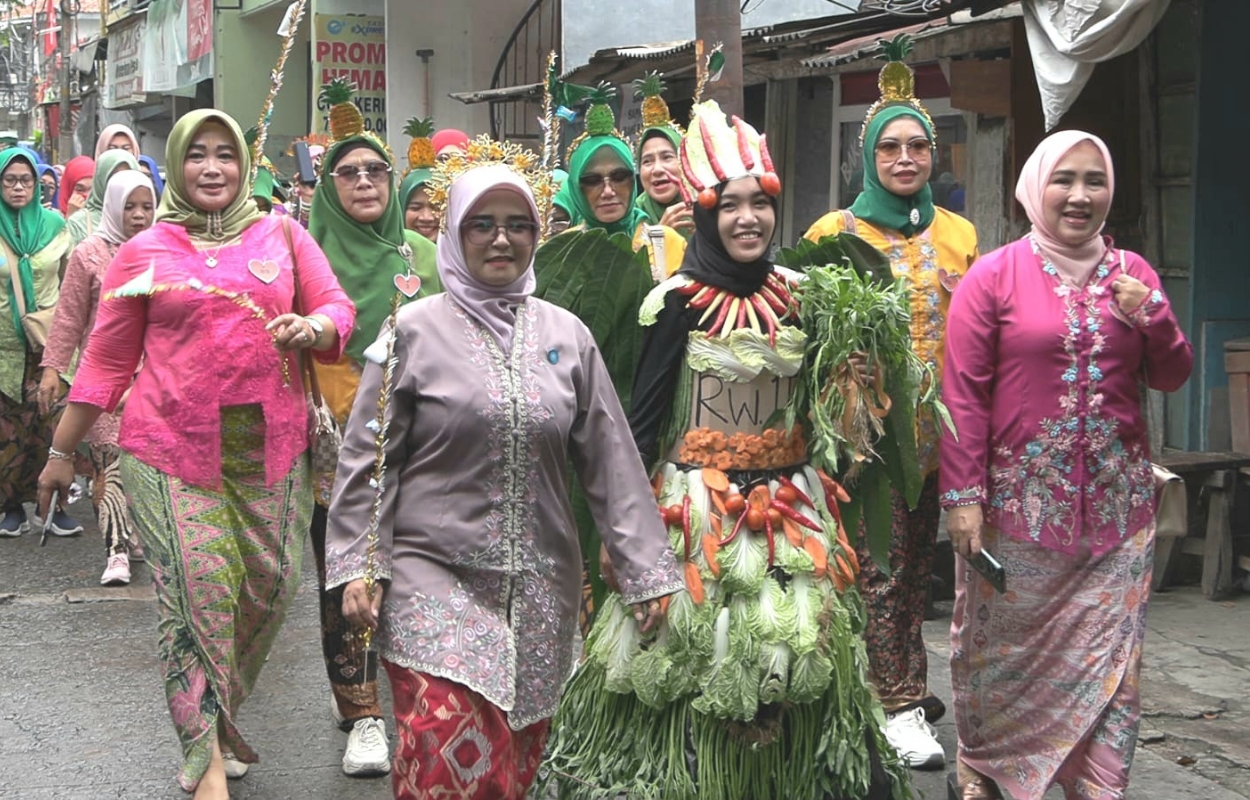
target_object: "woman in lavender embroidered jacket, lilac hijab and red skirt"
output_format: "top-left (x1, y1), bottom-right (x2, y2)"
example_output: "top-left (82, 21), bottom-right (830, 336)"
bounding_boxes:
top-left (326, 164), bottom-right (681, 800)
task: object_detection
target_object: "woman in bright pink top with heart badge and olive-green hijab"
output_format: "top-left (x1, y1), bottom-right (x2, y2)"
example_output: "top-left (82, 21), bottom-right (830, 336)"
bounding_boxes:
top-left (39, 109), bottom-right (355, 800)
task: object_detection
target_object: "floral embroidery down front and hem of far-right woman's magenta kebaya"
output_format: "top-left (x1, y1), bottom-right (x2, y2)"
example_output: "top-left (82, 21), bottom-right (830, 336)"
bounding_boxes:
top-left (989, 243), bottom-right (1154, 548)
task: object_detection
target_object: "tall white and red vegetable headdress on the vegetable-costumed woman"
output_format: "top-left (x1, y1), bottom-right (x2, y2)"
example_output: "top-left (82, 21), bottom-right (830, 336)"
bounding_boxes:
top-left (679, 100), bottom-right (781, 209)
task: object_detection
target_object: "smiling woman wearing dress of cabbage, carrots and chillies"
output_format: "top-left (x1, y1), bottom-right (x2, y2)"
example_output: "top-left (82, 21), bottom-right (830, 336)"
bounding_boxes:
top-left (537, 103), bottom-right (906, 800)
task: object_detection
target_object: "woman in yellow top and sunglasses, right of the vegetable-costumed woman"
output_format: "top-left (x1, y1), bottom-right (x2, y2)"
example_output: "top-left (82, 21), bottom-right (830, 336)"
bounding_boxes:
top-left (805, 36), bottom-right (978, 769)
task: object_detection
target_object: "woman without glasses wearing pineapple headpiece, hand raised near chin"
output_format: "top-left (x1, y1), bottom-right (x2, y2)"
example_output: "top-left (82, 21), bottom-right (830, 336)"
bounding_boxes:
top-left (634, 73), bottom-right (695, 241)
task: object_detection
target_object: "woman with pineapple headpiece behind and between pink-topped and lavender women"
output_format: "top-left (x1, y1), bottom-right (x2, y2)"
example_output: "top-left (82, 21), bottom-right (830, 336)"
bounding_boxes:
top-left (309, 81), bottom-right (441, 775)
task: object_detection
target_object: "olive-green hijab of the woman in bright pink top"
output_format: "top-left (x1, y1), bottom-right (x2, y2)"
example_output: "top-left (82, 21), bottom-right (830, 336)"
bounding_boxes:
top-left (156, 109), bottom-right (265, 239)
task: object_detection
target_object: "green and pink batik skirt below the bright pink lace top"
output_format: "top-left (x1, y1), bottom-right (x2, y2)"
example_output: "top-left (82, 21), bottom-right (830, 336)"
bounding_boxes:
top-left (121, 405), bottom-right (313, 791)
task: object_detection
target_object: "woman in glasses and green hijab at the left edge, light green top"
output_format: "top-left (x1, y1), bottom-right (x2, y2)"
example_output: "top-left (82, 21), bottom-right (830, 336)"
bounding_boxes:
top-left (0, 148), bottom-right (72, 538)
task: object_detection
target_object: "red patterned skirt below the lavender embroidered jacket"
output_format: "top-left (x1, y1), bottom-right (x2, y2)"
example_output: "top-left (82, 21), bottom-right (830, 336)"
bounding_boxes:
top-left (383, 661), bottom-right (550, 800)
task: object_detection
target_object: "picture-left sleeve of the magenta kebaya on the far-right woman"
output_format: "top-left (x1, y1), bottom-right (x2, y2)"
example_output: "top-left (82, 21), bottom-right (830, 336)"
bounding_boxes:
top-left (939, 254), bottom-right (999, 508)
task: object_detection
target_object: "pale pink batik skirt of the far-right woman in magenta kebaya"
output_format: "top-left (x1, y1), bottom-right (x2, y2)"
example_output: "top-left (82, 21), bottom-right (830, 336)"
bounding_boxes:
top-left (950, 528), bottom-right (1155, 800)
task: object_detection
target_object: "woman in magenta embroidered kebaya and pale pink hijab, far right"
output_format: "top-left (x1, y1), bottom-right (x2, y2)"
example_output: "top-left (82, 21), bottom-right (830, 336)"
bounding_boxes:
top-left (940, 131), bottom-right (1194, 800)
